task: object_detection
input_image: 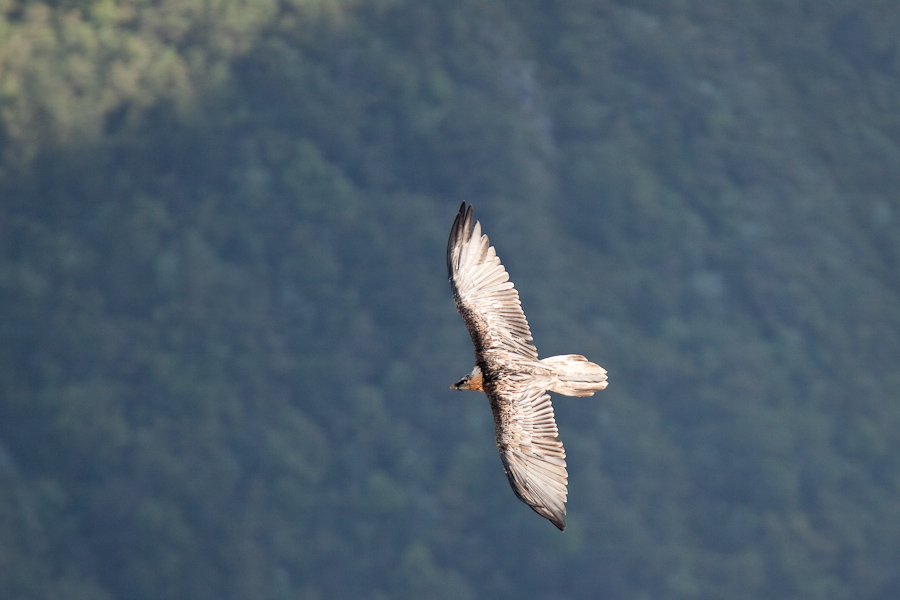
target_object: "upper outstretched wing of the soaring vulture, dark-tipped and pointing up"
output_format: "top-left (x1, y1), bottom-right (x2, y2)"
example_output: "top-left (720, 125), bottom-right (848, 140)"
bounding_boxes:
top-left (447, 202), bottom-right (537, 360)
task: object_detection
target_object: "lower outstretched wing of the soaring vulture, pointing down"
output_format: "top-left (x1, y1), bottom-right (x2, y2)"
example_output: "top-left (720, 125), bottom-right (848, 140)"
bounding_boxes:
top-left (492, 382), bottom-right (568, 530)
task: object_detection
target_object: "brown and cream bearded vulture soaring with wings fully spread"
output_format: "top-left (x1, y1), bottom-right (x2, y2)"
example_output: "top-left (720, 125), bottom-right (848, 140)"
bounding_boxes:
top-left (447, 202), bottom-right (607, 531)
